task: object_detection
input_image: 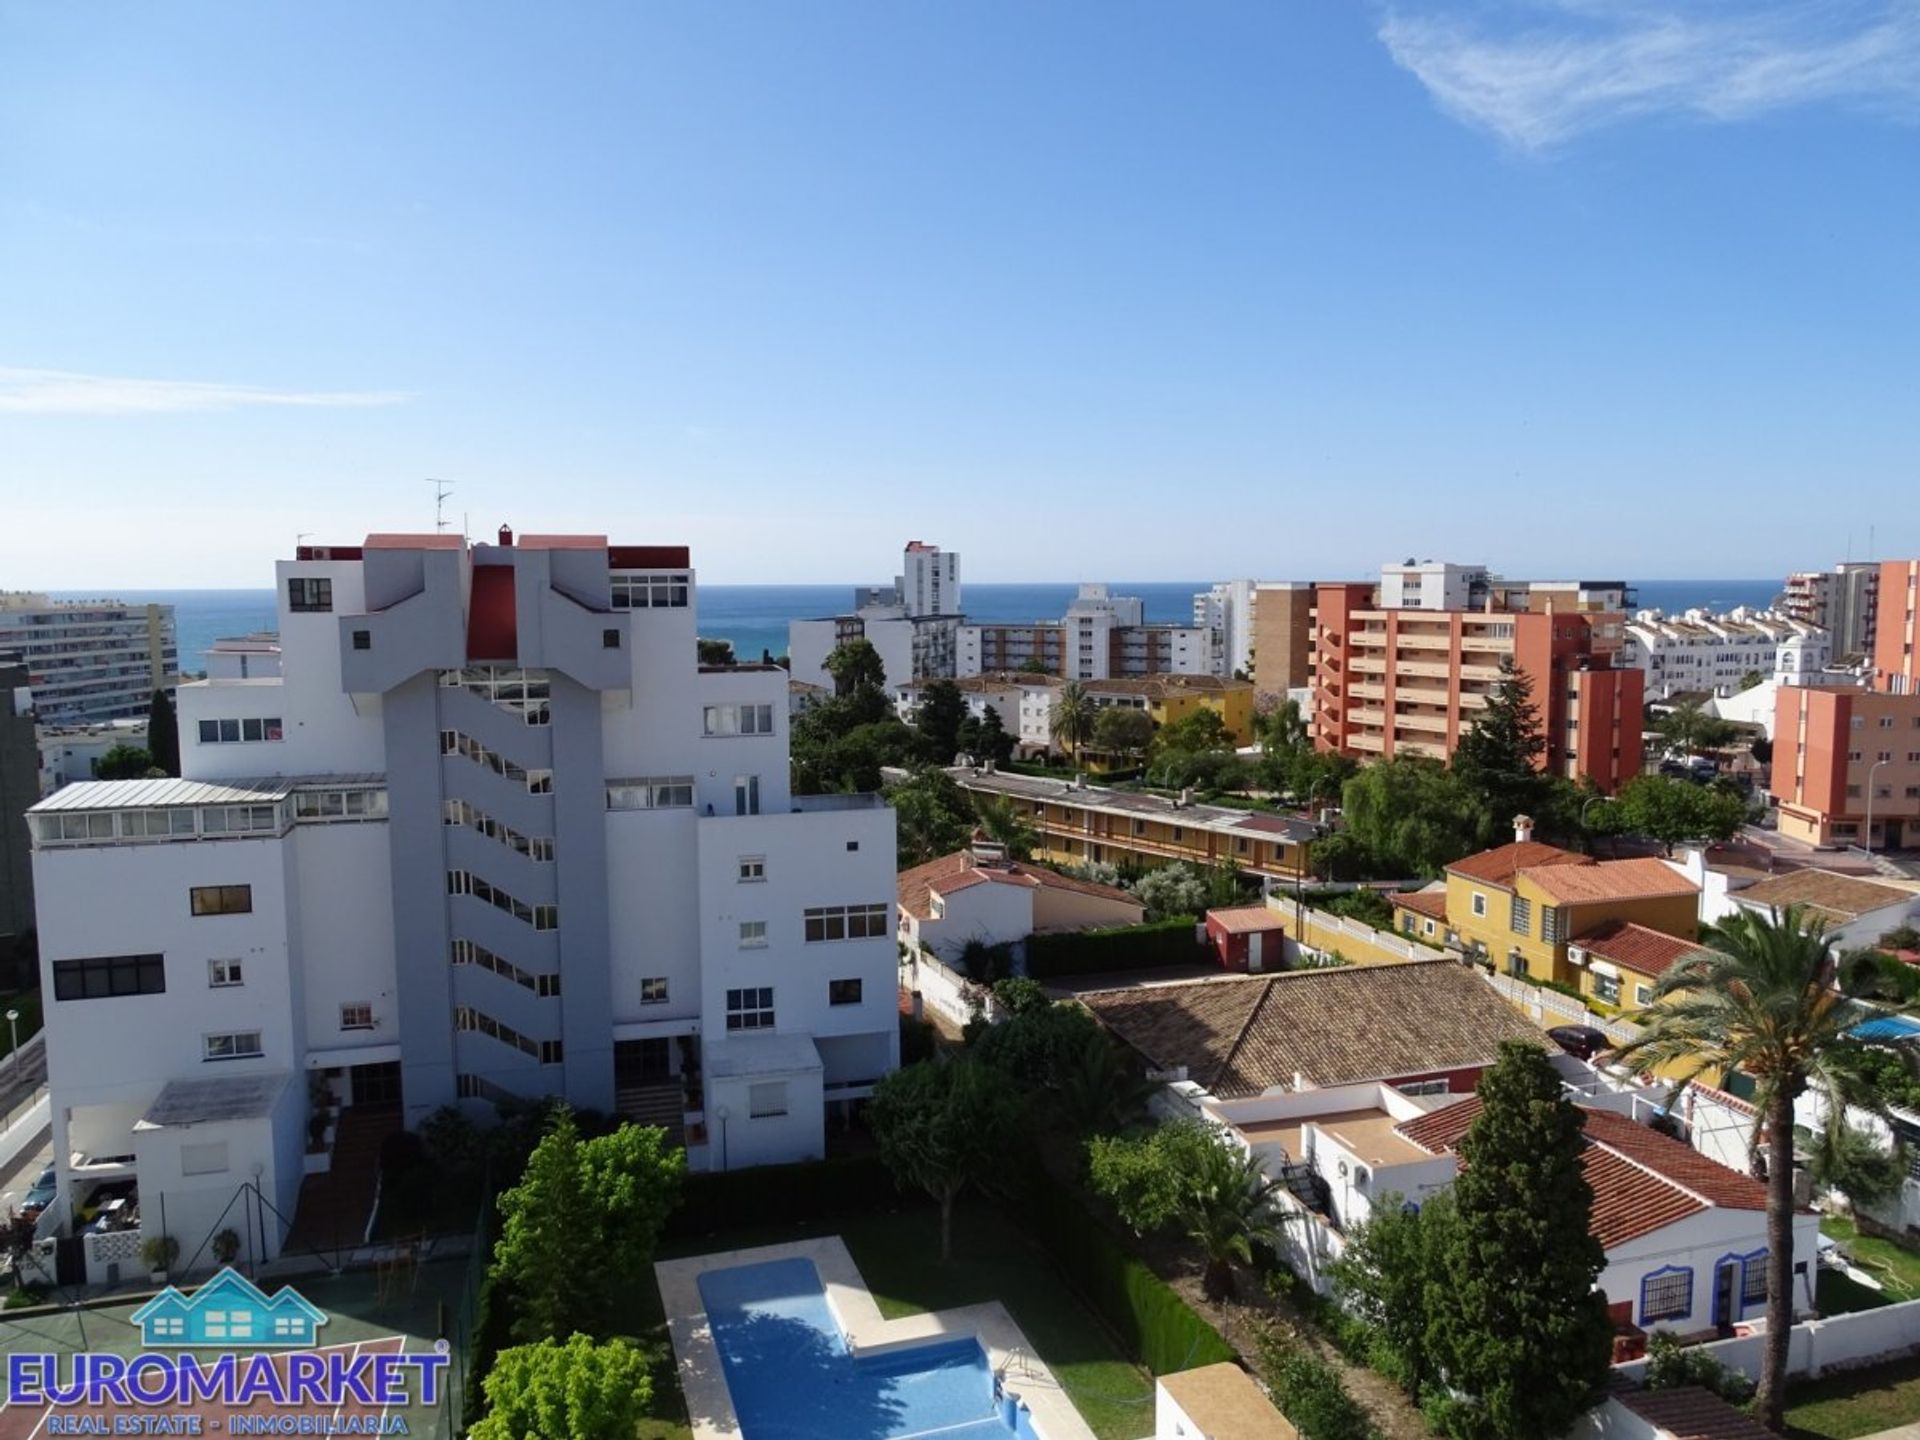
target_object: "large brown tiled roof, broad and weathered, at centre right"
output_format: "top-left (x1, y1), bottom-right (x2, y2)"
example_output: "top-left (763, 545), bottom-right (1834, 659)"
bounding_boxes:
top-left (1079, 960), bottom-right (1544, 1098)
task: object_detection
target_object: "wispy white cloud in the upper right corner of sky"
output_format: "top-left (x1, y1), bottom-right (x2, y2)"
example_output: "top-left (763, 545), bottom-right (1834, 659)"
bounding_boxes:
top-left (1380, 0), bottom-right (1920, 150)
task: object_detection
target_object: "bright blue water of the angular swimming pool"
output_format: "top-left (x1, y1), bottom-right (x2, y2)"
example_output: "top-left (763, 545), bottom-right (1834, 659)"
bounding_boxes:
top-left (699, 1260), bottom-right (1035, 1440)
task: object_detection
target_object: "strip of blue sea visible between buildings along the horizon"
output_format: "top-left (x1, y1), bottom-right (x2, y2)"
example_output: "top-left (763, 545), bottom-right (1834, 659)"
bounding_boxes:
top-left (67, 580), bottom-right (1780, 670)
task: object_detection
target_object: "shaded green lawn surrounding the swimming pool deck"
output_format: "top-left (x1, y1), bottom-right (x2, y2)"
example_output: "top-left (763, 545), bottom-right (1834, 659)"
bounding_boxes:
top-left (641, 1206), bottom-right (1154, 1440)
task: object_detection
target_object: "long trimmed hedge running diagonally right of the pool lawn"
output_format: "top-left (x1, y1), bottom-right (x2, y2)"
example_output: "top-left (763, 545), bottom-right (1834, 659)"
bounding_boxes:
top-left (1014, 1160), bottom-right (1240, 1375)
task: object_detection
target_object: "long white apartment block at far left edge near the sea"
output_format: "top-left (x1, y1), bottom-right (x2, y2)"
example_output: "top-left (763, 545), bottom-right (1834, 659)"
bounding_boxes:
top-left (0, 589), bottom-right (180, 726)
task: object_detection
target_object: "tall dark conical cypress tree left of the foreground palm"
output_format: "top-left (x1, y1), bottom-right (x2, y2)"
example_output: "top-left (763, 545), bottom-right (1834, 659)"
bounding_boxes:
top-left (1427, 1041), bottom-right (1613, 1440)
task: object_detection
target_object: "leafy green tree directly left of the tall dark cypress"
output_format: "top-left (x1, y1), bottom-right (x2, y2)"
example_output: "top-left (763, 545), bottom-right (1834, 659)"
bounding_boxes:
top-left (1332, 1192), bottom-right (1453, 1404)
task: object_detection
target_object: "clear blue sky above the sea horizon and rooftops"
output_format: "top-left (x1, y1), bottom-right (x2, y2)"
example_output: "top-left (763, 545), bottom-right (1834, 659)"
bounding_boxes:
top-left (0, 0), bottom-right (1920, 588)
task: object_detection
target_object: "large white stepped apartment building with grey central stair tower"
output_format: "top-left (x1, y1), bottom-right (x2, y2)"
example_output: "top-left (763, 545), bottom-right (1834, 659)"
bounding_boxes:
top-left (29, 530), bottom-right (899, 1274)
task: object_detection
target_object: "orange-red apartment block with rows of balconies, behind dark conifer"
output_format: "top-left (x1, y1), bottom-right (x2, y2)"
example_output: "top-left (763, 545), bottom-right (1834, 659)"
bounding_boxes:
top-left (1313, 584), bottom-right (1645, 793)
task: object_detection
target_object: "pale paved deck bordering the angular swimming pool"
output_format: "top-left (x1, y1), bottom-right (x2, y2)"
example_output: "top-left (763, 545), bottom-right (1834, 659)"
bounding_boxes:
top-left (653, 1236), bottom-right (1096, 1440)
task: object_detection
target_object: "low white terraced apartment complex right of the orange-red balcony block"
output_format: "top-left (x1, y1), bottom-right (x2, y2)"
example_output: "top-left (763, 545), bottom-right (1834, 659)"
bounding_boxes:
top-left (1615, 607), bottom-right (1832, 699)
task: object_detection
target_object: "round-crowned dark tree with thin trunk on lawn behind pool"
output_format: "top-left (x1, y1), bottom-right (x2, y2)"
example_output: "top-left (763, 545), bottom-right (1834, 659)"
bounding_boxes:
top-left (868, 1058), bottom-right (1020, 1261)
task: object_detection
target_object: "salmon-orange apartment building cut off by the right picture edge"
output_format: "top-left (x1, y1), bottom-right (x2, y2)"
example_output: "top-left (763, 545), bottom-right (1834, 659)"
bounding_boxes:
top-left (1772, 561), bottom-right (1920, 851)
